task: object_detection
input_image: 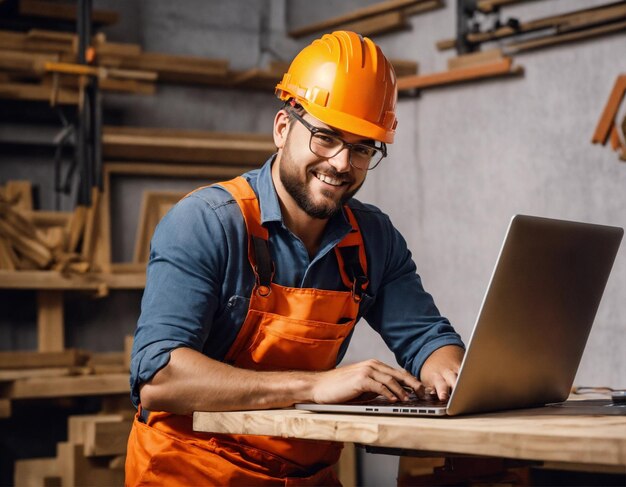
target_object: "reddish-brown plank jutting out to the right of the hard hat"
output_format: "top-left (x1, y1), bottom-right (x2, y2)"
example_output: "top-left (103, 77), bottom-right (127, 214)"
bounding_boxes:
top-left (398, 58), bottom-right (523, 91)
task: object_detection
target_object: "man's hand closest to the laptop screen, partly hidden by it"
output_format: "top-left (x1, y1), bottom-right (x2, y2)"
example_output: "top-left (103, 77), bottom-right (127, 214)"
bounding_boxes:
top-left (420, 345), bottom-right (465, 401)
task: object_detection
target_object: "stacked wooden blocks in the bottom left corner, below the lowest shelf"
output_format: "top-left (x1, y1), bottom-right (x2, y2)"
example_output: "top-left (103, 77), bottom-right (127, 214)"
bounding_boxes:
top-left (14, 414), bottom-right (132, 487)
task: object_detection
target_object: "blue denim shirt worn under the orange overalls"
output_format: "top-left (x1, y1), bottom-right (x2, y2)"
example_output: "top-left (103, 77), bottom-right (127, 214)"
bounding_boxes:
top-left (130, 158), bottom-right (463, 406)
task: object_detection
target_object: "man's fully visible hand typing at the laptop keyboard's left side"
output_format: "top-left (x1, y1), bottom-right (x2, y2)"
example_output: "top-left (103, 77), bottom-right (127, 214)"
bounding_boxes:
top-left (311, 360), bottom-right (423, 404)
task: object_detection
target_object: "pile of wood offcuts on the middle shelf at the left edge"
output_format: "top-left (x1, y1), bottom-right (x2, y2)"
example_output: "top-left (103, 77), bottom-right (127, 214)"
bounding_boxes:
top-left (0, 181), bottom-right (90, 273)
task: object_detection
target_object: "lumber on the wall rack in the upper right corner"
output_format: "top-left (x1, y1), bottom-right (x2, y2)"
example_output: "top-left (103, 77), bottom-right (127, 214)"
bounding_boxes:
top-left (437, 0), bottom-right (626, 55)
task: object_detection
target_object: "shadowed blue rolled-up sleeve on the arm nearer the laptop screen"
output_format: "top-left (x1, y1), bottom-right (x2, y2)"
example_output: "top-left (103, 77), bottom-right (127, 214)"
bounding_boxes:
top-left (364, 216), bottom-right (464, 377)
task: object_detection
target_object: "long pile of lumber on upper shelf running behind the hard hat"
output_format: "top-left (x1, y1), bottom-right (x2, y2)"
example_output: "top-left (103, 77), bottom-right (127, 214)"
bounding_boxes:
top-left (0, 26), bottom-right (417, 104)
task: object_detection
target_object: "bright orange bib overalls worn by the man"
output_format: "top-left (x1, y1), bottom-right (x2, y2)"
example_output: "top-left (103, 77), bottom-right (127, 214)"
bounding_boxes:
top-left (126, 177), bottom-right (367, 486)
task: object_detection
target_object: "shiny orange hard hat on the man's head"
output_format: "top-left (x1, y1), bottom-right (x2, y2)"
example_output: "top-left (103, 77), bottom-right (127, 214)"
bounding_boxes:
top-left (276, 31), bottom-right (398, 143)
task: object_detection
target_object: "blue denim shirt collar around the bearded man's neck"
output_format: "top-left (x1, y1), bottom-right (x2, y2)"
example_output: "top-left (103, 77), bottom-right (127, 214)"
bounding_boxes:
top-left (252, 154), bottom-right (352, 236)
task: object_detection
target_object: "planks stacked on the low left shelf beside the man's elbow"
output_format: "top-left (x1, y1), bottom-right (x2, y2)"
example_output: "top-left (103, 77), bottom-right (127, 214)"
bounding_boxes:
top-left (0, 337), bottom-right (132, 418)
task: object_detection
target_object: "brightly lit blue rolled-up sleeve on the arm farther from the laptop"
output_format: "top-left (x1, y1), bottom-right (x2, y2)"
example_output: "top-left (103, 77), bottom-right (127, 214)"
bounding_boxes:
top-left (130, 195), bottom-right (227, 406)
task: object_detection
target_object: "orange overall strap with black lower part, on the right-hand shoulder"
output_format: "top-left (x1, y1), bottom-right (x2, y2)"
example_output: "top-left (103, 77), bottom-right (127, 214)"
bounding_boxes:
top-left (335, 205), bottom-right (369, 301)
